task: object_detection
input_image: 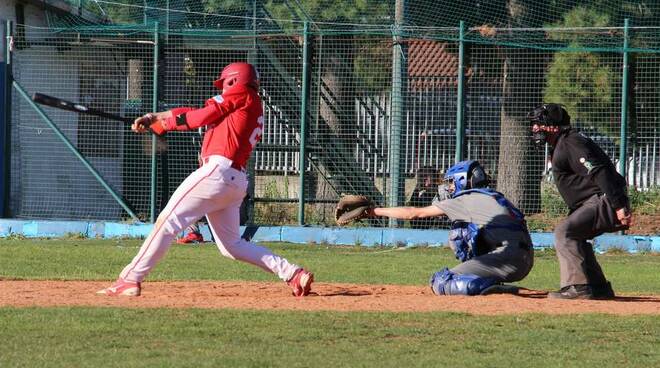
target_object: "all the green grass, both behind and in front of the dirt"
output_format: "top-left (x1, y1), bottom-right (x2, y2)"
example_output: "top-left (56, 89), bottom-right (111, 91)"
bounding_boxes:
top-left (0, 239), bottom-right (660, 367)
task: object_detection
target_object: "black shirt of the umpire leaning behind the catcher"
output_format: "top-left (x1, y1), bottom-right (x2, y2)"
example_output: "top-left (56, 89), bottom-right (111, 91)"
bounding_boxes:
top-left (552, 129), bottom-right (628, 211)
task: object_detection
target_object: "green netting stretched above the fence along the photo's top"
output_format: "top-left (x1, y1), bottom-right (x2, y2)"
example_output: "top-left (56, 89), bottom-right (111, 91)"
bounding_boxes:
top-left (50, 0), bottom-right (660, 51)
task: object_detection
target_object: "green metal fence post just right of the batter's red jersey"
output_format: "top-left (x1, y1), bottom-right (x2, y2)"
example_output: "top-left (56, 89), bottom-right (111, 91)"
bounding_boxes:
top-left (298, 22), bottom-right (310, 226)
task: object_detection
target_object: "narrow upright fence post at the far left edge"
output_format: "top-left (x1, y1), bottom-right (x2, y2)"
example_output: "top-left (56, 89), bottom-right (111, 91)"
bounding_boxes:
top-left (0, 20), bottom-right (14, 217)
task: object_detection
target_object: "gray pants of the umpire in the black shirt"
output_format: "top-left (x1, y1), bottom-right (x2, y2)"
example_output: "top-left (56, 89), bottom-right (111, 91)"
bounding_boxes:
top-left (555, 195), bottom-right (618, 287)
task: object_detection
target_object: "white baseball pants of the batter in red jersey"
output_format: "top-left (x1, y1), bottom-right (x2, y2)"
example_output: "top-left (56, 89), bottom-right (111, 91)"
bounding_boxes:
top-left (120, 156), bottom-right (299, 282)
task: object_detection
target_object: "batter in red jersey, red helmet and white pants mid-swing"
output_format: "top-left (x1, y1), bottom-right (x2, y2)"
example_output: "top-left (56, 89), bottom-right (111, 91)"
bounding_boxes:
top-left (98, 62), bottom-right (314, 296)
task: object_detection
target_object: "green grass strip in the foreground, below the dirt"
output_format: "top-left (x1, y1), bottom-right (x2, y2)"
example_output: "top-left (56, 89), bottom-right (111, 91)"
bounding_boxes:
top-left (0, 308), bottom-right (660, 368)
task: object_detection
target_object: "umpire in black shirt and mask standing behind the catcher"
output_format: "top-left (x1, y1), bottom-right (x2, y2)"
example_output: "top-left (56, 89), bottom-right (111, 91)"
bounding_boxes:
top-left (528, 103), bottom-right (632, 299)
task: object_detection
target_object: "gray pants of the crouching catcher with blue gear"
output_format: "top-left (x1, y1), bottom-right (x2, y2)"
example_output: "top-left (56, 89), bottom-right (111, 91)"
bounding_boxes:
top-left (450, 235), bottom-right (534, 282)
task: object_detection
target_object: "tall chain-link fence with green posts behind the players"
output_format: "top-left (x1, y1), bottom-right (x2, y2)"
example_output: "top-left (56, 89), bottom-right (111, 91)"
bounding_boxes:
top-left (2, 2), bottom-right (660, 227)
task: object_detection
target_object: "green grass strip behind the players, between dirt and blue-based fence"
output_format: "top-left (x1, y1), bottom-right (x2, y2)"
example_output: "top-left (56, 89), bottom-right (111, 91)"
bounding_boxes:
top-left (0, 239), bottom-right (660, 294)
